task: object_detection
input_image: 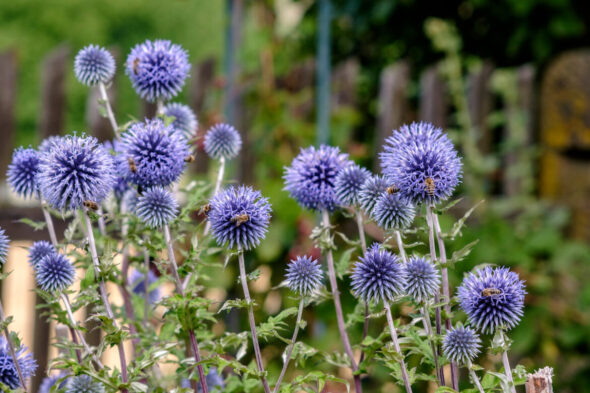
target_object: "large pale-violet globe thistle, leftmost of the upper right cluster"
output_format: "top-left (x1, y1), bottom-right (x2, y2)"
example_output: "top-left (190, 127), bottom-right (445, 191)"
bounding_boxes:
top-left (283, 145), bottom-right (349, 211)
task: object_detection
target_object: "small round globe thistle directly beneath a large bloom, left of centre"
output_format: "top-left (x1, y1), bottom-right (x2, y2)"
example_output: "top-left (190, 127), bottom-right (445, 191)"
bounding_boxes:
top-left (135, 187), bottom-right (178, 228)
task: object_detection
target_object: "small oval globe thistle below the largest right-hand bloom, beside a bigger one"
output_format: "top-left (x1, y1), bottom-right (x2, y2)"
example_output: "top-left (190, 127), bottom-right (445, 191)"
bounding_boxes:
top-left (404, 256), bottom-right (440, 303)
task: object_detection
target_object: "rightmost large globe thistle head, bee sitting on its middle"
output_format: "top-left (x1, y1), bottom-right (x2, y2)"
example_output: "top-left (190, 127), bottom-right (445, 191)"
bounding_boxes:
top-left (458, 266), bottom-right (526, 333)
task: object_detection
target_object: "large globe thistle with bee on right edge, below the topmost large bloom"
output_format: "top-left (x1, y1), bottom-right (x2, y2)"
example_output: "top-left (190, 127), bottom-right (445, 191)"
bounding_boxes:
top-left (122, 119), bottom-right (189, 188)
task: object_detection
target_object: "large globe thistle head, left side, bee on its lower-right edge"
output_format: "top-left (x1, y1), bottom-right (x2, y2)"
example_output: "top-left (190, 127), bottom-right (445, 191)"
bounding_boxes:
top-left (38, 136), bottom-right (116, 210)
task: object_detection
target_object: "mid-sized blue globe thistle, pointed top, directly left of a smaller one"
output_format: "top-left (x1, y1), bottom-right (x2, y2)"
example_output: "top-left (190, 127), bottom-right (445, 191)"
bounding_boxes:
top-left (351, 243), bottom-right (406, 302)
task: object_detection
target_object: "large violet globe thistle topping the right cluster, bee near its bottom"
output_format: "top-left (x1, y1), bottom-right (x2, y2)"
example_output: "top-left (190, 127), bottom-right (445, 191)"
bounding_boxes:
top-left (380, 123), bottom-right (462, 204)
